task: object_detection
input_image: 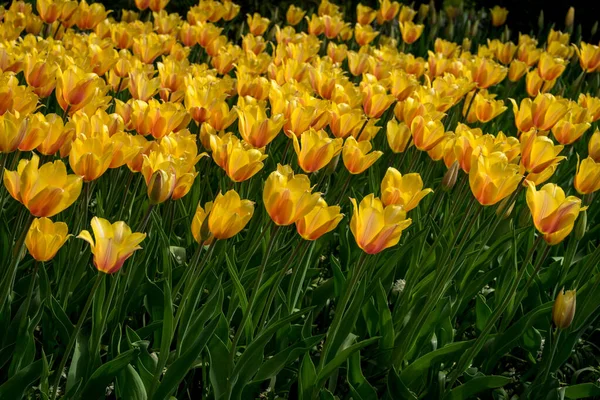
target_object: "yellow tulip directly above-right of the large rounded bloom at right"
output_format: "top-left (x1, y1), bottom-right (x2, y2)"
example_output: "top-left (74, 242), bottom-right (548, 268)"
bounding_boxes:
top-left (521, 130), bottom-right (566, 174)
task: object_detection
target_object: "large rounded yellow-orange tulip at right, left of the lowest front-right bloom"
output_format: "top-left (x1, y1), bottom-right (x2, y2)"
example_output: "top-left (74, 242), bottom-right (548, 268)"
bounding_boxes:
top-left (469, 152), bottom-right (522, 206)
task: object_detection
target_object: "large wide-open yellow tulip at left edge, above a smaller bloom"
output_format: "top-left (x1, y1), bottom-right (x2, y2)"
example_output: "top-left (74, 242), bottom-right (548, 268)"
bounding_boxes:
top-left (4, 154), bottom-right (82, 217)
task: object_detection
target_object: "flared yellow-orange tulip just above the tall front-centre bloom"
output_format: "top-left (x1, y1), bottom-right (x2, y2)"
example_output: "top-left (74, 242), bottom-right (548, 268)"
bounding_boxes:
top-left (292, 128), bottom-right (344, 173)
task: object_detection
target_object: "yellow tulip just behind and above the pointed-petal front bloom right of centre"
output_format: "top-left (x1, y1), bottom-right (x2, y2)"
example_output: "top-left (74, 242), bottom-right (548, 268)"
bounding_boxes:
top-left (381, 167), bottom-right (433, 212)
